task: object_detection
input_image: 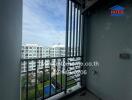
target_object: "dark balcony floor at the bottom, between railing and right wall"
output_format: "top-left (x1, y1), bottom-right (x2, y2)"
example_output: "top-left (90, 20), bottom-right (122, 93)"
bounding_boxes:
top-left (65, 91), bottom-right (99, 100)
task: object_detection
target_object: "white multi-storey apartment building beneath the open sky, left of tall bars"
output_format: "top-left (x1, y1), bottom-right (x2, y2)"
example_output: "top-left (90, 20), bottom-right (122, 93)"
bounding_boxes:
top-left (21, 44), bottom-right (65, 73)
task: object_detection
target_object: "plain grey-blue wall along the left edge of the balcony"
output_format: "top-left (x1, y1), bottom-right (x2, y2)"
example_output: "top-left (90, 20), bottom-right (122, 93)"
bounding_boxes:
top-left (0, 0), bottom-right (22, 100)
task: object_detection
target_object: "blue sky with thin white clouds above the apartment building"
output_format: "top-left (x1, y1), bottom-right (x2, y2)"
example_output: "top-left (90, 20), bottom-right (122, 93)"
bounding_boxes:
top-left (23, 0), bottom-right (66, 46)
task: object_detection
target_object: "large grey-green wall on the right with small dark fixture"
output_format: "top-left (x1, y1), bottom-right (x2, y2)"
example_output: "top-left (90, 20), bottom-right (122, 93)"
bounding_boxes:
top-left (84, 0), bottom-right (132, 100)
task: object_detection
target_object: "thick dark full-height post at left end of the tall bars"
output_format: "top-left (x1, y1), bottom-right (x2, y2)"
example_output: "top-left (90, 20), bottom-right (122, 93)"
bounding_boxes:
top-left (65, 0), bottom-right (69, 93)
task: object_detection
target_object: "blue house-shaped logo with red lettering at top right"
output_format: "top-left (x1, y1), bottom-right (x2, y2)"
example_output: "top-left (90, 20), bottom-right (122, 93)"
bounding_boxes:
top-left (110, 5), bottom-right (125, 16)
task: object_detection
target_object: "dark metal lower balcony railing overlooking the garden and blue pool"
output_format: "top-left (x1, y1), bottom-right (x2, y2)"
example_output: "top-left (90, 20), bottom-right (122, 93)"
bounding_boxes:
top-left (21, 56), bottom-right (81, 100)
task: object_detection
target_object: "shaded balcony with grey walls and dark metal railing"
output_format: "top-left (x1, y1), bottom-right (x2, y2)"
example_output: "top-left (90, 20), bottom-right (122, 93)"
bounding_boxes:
top-left (0, 0), bottom-right (132, 100)
